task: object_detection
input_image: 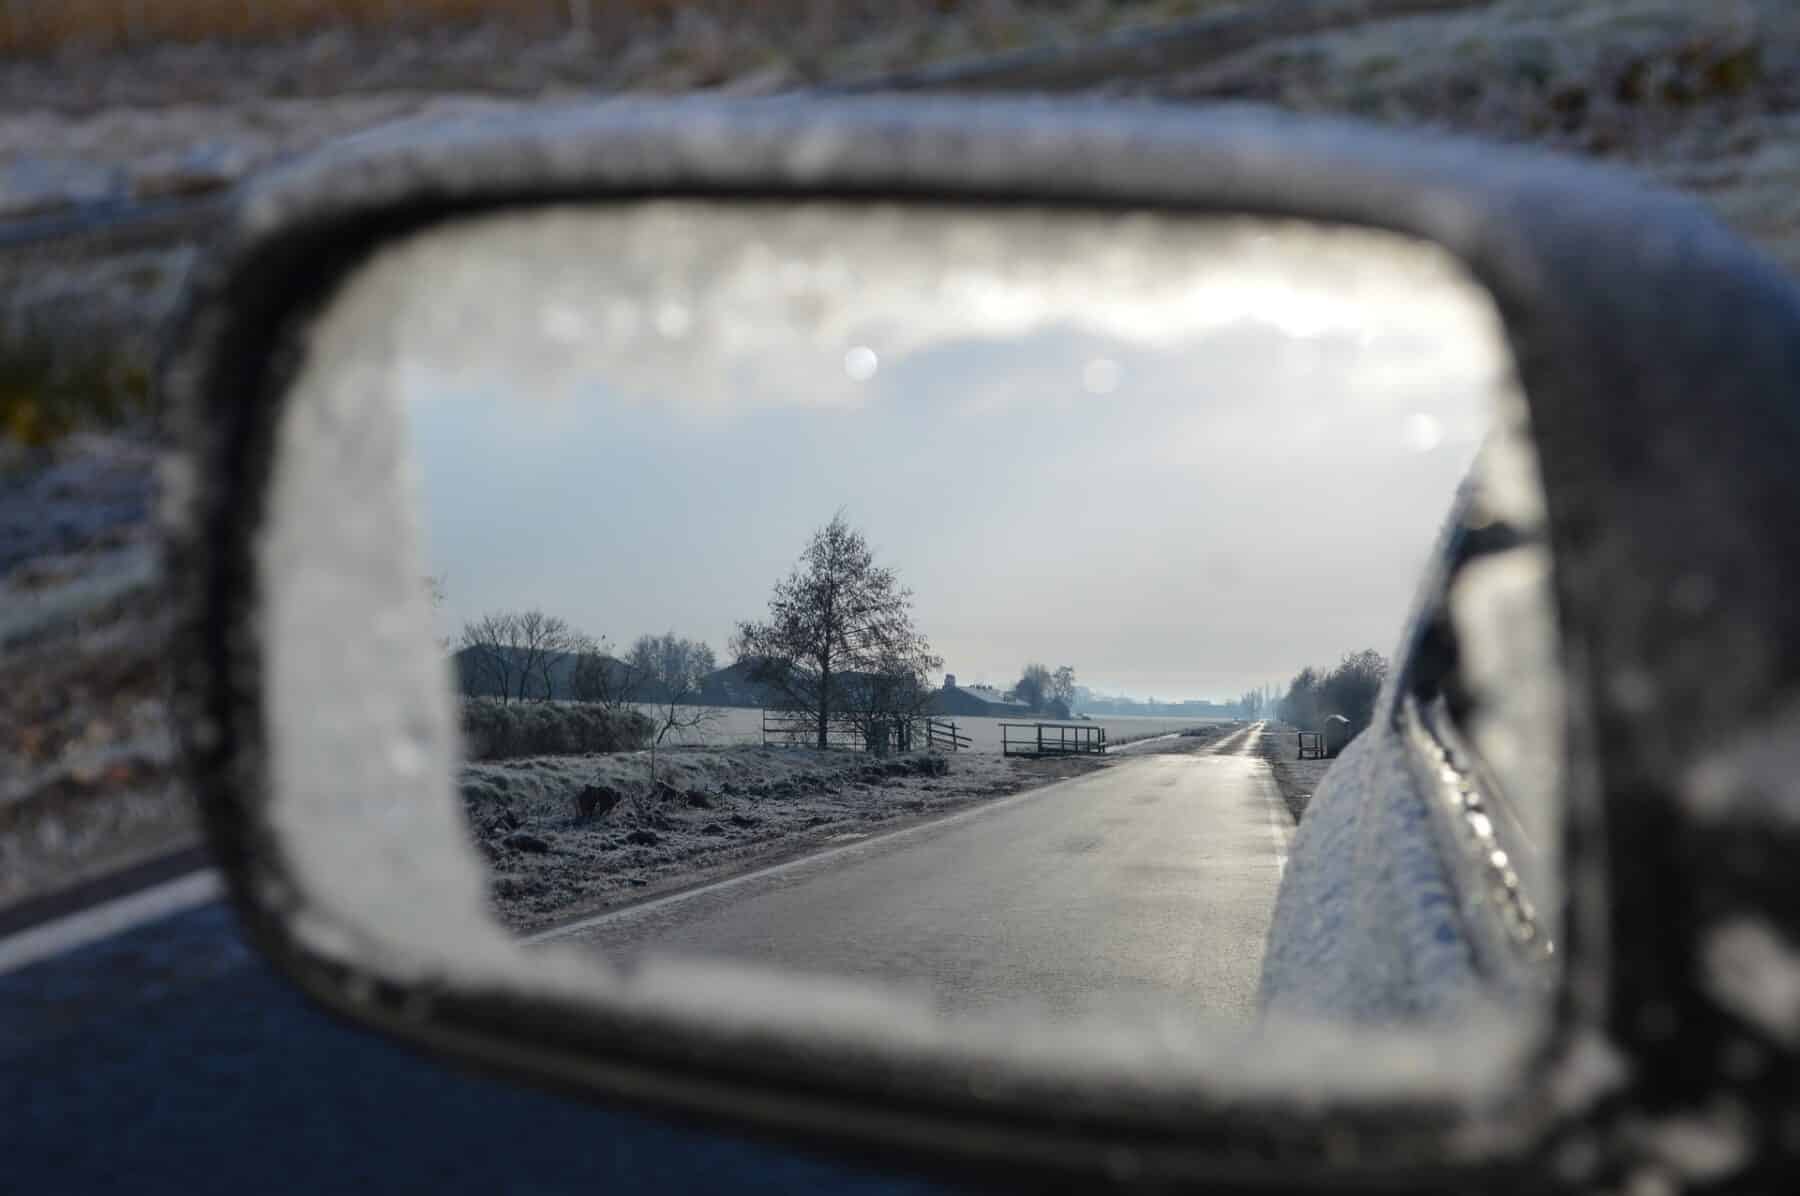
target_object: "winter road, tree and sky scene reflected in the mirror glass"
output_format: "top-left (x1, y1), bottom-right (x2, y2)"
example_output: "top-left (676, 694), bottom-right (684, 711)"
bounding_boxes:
top-left (291, 202), bottom-right (1559, 1019)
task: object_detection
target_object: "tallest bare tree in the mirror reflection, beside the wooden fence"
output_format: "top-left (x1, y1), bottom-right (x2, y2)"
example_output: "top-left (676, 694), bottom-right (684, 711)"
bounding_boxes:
top-left (733, 512), bottom-right (943, 749)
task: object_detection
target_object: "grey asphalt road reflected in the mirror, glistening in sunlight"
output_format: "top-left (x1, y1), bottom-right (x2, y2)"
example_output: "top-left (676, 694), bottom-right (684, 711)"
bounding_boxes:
top-left (536, 729), bottom-right (1292, 1018)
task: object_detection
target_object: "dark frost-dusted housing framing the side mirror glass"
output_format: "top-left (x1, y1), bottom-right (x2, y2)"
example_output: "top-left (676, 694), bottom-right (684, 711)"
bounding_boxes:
top-left (151, 99), bottom-right (1800, 1189)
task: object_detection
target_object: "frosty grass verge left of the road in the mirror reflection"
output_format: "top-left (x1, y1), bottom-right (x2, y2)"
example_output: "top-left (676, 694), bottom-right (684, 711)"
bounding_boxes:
top-left (461, 746), bottom-right (1109, 929)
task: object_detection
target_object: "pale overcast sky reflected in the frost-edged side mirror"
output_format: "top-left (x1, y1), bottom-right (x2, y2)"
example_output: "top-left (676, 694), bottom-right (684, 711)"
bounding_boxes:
top-left (364, 205), bottom-right (1503, 701)
